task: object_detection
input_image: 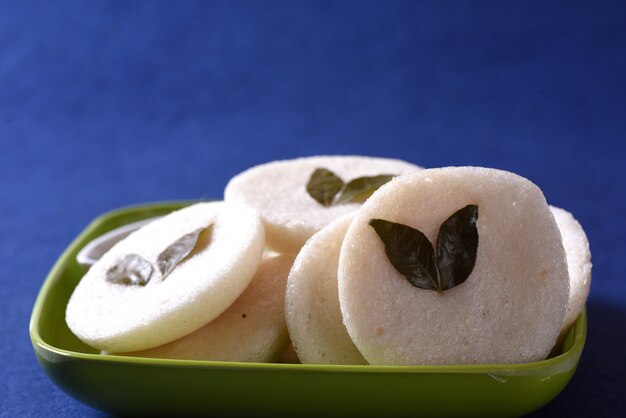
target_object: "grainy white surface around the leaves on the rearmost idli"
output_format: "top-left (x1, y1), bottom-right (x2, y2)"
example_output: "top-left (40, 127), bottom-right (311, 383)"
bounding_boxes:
top-left (224, 156), bottom-right (420, 252)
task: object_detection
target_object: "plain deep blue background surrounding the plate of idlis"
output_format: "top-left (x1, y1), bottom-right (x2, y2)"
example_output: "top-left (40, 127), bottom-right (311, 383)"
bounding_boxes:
top-left (0, 1), bottom-right (626, 417)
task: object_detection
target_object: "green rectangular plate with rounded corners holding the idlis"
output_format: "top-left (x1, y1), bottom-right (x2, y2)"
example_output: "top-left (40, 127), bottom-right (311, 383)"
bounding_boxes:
top-left (30, 202), bottom-right (587, 417)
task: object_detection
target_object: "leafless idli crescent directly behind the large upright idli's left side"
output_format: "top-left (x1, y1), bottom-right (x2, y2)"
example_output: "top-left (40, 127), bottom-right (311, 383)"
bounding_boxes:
top-left (285, 215), bottom-right (367, 364)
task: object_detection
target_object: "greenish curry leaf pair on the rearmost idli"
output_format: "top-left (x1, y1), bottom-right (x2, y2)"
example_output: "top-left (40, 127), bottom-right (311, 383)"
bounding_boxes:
top-left (306, 168), bottom-right (394, 207)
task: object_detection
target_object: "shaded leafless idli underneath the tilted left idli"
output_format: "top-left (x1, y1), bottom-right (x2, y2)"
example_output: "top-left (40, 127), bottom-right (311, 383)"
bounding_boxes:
top-left (125, 254), bottom-right (293, 362)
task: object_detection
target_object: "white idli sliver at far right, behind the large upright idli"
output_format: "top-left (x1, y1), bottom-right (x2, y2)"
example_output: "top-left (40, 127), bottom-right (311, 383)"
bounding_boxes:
top-left (550, 206), bottom-right (591, 332)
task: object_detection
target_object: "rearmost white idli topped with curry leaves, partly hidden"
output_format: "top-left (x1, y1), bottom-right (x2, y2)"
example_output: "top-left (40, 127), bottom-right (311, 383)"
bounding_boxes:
top-left (224, 156), bottom-right (420, 252)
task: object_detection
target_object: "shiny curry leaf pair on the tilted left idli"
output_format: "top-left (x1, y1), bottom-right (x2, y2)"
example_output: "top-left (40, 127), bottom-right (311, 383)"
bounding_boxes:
top-left (106, 224), bottom-right (213, 286)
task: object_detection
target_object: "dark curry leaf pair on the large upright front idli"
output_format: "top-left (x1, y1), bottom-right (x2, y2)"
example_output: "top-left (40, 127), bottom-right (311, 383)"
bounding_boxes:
top-left (369, 205), bottom-right (478, 293)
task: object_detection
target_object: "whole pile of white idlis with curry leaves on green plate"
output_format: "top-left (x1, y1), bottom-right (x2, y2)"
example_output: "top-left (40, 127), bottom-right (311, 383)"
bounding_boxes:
top-left (66, 156), bottom-right (591, 365)
